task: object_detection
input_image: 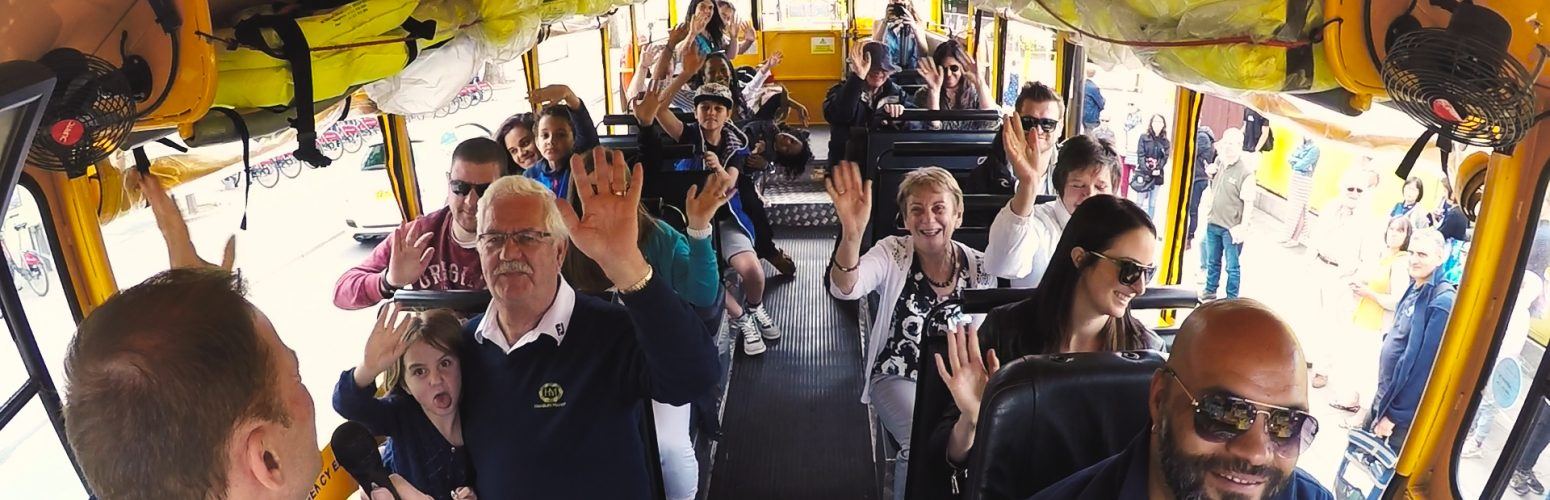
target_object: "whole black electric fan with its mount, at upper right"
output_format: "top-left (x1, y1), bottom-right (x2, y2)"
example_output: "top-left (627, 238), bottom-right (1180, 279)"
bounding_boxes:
top-left (1383, 3), bottom-right (1544, 147)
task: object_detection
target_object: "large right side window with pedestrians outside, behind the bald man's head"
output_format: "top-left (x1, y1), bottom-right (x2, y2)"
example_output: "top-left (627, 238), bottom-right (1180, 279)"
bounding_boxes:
top-left (1171, 96), bottom-right (1471, 498)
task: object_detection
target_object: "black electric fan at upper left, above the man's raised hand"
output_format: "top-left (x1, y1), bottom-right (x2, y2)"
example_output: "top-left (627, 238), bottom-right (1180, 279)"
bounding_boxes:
top-left (26, 48), bottom-right (146, 178)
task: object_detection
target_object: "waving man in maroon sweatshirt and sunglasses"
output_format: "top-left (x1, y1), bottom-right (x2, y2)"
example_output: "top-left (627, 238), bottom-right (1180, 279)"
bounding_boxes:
top-left (333, 138), bottom-right (510, 310)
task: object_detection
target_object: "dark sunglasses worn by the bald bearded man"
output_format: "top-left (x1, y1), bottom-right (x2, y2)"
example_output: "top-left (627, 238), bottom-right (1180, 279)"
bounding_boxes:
top-left (1163, 367), bottom-right (1319, 458)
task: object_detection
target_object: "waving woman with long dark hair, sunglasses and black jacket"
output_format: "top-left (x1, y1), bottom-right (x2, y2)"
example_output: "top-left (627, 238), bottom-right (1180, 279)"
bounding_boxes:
top-left (932, 195), bottom-right (1163, 464)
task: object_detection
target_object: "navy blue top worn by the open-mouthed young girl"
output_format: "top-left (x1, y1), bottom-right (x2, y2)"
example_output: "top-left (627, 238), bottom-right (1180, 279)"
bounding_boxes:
top-left (333, 368), bottom-right (477, 498)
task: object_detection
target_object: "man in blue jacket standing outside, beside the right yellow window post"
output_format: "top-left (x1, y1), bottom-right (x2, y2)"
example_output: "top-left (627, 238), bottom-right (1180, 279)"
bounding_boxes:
top-left (1370, 229), bottom-right (1459, 452)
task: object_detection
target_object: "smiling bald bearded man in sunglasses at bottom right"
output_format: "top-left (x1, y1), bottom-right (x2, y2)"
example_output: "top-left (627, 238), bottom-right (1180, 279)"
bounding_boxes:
top-left (1034, 299), bottom-right (1333, 500)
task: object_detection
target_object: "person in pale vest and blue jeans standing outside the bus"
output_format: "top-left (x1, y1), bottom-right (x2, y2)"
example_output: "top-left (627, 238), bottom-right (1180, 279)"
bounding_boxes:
top-left (1200, 128), bottom-right (1259, 302)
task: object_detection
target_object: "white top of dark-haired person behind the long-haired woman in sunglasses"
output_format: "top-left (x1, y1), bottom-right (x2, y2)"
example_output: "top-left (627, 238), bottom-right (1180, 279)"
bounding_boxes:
top-left (984, 200), bottom-right (1071, 288)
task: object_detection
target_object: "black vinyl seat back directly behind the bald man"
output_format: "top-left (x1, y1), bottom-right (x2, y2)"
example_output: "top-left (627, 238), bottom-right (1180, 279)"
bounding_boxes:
top-left (967, 351), bottom-right (1164, 500)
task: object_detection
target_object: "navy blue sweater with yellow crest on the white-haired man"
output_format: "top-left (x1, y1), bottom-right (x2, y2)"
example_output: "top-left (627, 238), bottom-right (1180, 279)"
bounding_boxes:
top-left (462, 274), bottom-right (718, 500)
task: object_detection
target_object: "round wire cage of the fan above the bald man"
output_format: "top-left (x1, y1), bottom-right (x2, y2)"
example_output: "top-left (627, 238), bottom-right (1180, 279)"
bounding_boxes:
top-left (1383, 28), bottom-right (1535, 147)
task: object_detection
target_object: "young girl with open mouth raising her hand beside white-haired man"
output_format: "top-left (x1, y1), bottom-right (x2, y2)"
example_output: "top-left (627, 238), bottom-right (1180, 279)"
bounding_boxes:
top-left (333, 303), bottom-right (476, 500)
